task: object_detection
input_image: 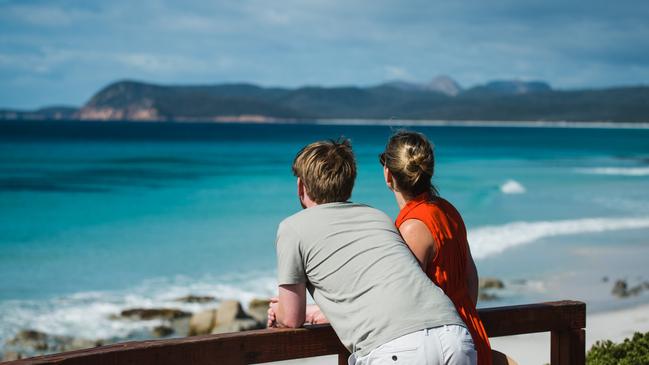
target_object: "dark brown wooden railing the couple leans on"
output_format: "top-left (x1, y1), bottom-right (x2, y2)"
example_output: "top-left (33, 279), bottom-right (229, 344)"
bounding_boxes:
top-left (6, 301), bottom-right (586, 365)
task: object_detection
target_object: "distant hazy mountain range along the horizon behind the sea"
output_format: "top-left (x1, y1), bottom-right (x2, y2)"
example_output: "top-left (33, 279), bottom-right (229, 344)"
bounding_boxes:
top-left (0, 76), bottom-right (649, 122)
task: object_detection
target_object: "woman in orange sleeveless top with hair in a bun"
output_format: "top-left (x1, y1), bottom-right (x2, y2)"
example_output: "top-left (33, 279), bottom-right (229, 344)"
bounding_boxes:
top-left (380, 131), bottom-right (492, 365)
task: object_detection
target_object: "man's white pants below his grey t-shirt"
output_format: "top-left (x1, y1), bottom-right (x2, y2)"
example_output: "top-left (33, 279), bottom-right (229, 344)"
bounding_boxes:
top-left (349, 325), bottom-right (478, 365)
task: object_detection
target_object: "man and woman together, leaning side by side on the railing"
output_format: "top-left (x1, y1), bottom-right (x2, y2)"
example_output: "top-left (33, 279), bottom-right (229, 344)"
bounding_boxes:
top-left (268, 131), bottom-right (511, 365)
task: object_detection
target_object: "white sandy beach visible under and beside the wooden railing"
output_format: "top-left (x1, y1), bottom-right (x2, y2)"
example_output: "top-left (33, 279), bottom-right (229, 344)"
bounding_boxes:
top-left (274, 304), bottom-right (649, 365)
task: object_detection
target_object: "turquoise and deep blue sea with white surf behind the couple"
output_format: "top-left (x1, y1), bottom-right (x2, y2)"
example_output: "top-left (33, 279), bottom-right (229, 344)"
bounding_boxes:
top-left (0, 122), bottom-right (649, 348)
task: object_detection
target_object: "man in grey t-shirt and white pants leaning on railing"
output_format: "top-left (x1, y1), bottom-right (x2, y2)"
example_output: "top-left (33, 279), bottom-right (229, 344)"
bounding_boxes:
top-left (269, 140), bottom-right (476, 365)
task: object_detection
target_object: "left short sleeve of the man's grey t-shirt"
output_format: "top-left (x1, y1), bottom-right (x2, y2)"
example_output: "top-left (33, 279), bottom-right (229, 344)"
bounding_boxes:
top-left (275, 222), bottom-right (307, 285)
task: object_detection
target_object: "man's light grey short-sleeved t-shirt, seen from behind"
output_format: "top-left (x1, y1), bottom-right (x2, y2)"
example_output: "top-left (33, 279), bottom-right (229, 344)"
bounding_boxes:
top-left (276, 203), bottom-right (464, 356)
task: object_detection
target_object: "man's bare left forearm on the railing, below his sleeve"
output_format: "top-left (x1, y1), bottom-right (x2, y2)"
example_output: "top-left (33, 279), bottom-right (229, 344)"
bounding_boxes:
top-left (270, 283), bottom-right (306, 328)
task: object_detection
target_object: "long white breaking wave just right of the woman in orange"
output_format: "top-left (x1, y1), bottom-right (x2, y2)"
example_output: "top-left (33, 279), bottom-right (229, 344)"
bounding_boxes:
top-left (468, 217), bottom-right (649, 259)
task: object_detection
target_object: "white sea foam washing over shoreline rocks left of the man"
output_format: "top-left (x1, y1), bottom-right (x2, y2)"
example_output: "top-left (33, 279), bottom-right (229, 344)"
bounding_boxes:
top-left (0, 272), bottom-right (277, 346)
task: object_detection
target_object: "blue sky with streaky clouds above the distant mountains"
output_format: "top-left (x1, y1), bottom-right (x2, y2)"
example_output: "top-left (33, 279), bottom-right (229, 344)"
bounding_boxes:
top-left (0, 0), bottom-right (649, 108)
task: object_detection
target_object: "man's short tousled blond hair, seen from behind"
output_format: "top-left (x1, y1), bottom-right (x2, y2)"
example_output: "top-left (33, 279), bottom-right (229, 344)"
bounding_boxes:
top-left (293, 138), bottom-right (356, 204)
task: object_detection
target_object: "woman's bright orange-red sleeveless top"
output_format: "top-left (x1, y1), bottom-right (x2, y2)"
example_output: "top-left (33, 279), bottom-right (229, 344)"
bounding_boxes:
top-left (396, 193), bottom-right (491, 365)
